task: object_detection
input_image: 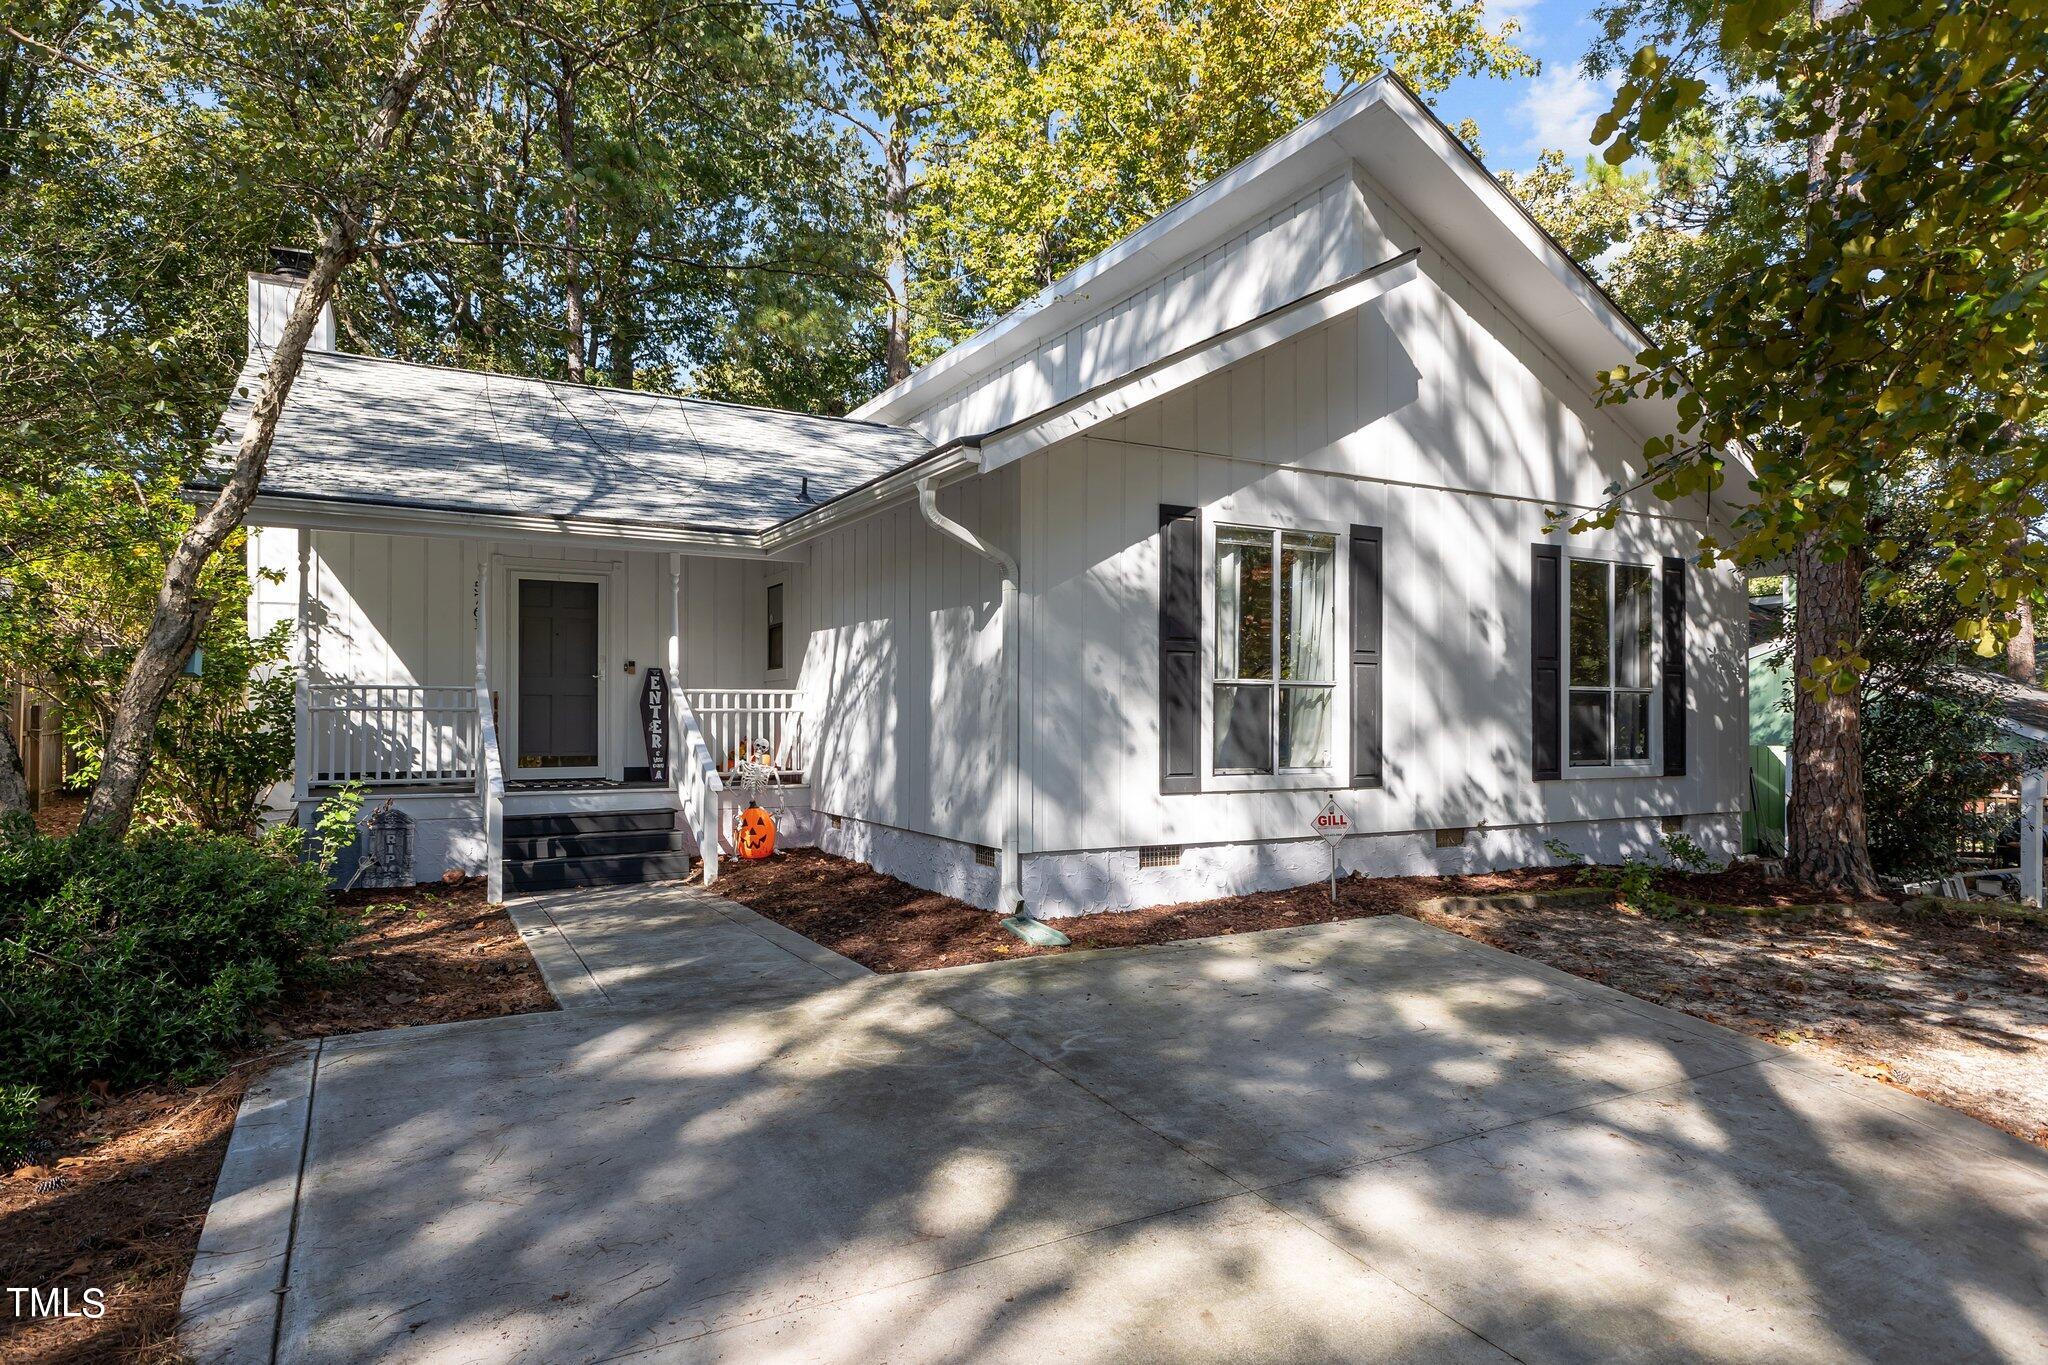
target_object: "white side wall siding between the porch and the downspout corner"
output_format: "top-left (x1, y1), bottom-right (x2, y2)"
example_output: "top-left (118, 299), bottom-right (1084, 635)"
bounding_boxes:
top-left (801, 471), bottom-right (1018, 845)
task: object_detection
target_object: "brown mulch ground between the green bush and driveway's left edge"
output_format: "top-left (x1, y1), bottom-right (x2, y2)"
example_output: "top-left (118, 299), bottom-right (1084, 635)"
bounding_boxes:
top-left (0, 880), bottom-right (555, 1365)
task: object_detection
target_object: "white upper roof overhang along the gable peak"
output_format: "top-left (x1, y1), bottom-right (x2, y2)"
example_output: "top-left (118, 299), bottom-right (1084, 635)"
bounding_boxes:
top-left (852, 74), bottom-right (1677, 456)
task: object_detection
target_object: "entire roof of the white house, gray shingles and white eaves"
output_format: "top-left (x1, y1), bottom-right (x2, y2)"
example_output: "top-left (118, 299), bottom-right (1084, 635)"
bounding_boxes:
top-left (223, 74), bottom-right (1712, 553)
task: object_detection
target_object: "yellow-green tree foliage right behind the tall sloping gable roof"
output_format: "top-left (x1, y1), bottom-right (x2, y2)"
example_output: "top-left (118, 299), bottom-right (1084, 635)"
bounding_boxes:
top-left (897, 0), bottom-right (1534, 356)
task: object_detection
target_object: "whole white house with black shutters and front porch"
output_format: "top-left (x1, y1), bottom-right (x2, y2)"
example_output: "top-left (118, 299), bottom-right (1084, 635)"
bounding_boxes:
top-left (229, 78), bottom-right (1747, 915)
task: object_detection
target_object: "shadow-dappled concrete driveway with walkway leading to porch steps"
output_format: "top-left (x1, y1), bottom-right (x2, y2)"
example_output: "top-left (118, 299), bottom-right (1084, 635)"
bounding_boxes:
top-left (186, 886), bottom-right (2048, 1365)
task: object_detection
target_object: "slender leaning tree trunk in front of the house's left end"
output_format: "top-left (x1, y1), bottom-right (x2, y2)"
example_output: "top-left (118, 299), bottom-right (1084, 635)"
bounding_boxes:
top-left (80, 0), bottom-right (467, 835)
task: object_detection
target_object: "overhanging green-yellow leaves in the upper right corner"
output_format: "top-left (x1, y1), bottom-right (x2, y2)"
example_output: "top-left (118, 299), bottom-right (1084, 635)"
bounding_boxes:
top-left (1595, 0), bottom-right (2048, 654)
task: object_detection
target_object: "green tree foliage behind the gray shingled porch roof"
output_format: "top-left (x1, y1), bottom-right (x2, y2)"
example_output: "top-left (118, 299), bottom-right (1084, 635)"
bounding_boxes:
top-left (338, 0), bottom-right (879, 411)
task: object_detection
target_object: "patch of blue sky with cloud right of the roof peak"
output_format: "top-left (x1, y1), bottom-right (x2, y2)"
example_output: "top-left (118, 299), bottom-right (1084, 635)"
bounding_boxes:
top-left (1436, 0), bottom-right (1608, 170)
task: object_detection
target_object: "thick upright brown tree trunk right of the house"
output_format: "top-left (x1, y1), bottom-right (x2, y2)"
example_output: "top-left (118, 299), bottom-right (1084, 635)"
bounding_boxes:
top-left (1786, 536), bottom-right (1880, 900)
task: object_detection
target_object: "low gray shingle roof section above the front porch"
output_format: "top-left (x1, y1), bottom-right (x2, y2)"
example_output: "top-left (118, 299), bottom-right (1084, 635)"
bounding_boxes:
top-left (223, 352), bottom-right (932, 530)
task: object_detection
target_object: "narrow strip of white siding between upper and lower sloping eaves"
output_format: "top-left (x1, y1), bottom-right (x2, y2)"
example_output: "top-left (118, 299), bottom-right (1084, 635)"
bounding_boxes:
top-left (901, 174), bottom-right (1395, 444)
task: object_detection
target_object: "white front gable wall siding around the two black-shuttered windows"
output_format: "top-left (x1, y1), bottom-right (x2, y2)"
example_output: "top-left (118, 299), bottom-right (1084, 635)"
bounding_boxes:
top-left (1022, 256), bottom-right (1745, 851)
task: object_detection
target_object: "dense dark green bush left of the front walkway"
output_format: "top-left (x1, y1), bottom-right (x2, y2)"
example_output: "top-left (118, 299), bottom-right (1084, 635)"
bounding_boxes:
top-left (0, 821), bottom-right (352, 1162)
